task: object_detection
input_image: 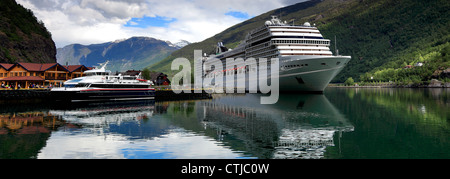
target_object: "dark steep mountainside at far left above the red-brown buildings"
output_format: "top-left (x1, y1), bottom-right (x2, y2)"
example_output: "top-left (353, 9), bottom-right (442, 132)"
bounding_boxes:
top-left (0, 0), bottom-right (56, 63)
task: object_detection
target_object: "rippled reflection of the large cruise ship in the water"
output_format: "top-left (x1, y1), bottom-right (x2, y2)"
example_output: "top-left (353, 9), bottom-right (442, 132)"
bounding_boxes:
top-left (197, 94), bottom-right (353, 158)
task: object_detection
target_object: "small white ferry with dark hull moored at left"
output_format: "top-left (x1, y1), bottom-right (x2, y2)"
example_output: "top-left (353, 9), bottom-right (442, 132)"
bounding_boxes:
top-left (51, 62), bottom-right (155, 101)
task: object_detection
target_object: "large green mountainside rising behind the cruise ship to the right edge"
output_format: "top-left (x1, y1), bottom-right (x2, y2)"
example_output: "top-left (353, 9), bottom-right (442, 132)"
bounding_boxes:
top-left (149, 0), bottom-right (450, 82)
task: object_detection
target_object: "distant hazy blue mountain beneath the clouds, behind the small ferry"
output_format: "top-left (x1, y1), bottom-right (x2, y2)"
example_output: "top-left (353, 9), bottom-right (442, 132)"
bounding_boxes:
top-left (56, 37), bottom-right (179, 71)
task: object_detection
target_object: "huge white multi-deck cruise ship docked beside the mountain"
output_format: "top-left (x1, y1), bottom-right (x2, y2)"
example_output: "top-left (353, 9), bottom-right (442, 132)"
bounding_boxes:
top-left (197, 16), bottom-right (351, 93)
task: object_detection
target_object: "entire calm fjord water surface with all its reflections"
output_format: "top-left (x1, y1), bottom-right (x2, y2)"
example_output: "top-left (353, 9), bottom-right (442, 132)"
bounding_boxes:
top-left (0, 88), bottom-right (450, 159)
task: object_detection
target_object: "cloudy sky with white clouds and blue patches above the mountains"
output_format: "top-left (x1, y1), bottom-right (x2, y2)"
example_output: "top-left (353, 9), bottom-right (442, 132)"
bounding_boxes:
top-left (17, 0), bottom-right (304, 47)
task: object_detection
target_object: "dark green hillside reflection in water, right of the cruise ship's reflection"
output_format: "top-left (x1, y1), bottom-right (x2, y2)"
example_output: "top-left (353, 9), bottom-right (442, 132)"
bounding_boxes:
top-left (325, 88), bottom-right (450, 159)
